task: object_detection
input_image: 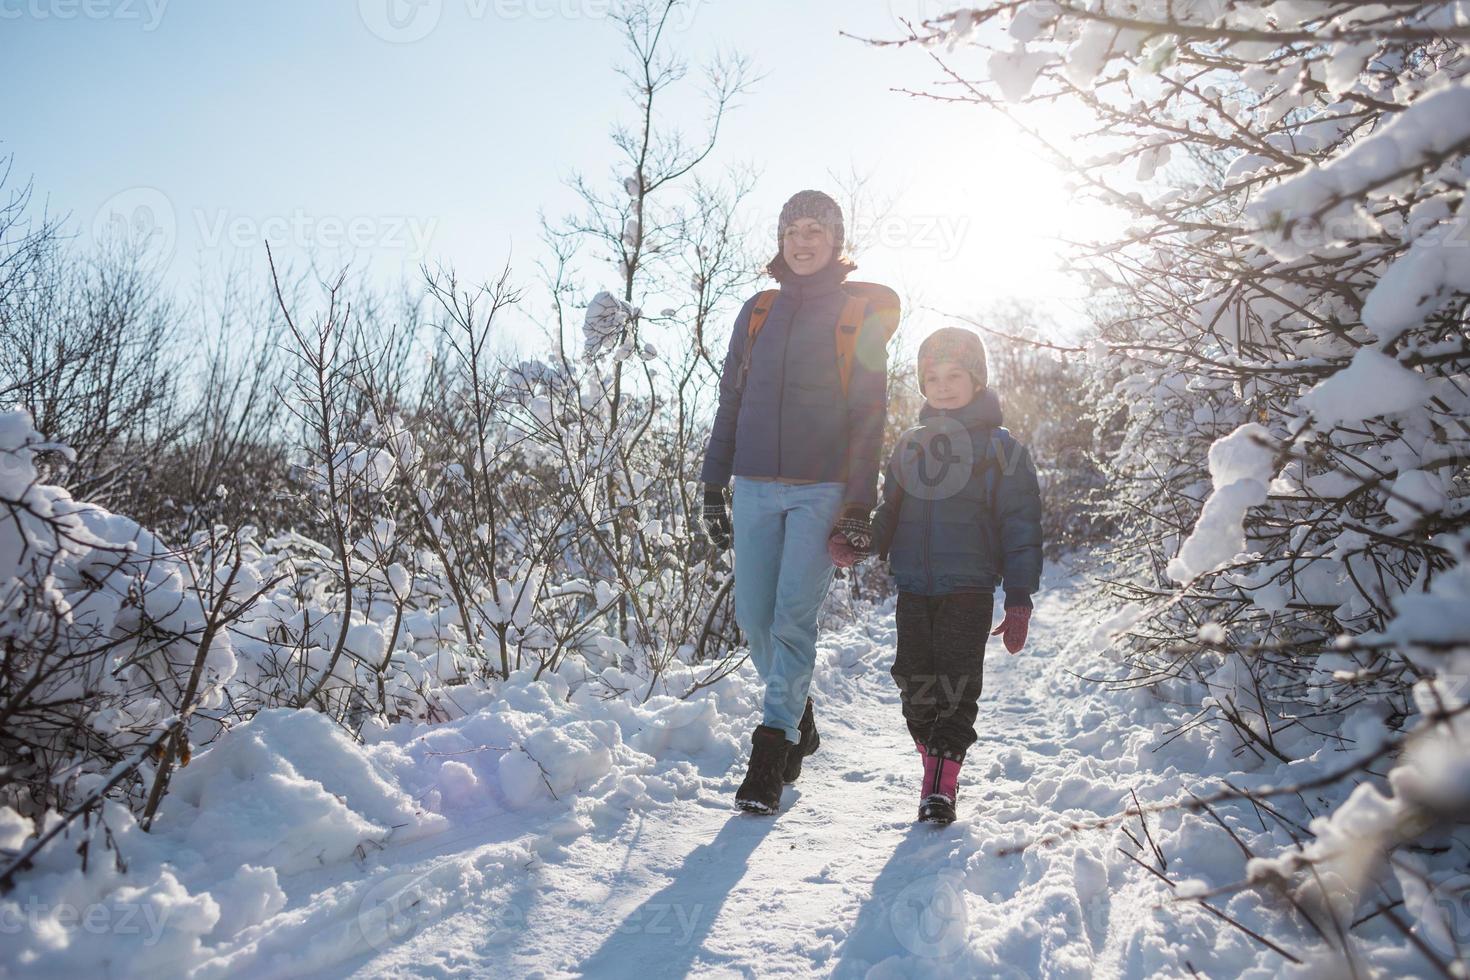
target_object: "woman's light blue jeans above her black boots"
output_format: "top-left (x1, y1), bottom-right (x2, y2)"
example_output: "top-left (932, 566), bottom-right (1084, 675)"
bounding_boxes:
top-left (731, 476), bottom-right (847, 742)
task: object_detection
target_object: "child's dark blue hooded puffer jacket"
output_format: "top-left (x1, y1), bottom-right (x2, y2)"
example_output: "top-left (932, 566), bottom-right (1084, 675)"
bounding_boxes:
top-left (873, 388), bottom-right (1041, 607)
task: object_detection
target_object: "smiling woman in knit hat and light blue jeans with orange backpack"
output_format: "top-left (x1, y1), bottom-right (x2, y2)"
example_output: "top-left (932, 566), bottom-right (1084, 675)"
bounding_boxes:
top-left (700, 191), bottom-right (888, 814)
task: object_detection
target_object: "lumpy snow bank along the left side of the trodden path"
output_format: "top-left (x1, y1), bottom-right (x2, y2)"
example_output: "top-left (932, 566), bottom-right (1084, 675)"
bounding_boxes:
top-left (0, 643), bottom-right (756, 977)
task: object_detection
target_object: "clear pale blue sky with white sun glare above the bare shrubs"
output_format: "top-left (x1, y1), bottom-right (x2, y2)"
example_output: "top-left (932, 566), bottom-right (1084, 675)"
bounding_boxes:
top-left (0, 0), bottom-right (1105, 346)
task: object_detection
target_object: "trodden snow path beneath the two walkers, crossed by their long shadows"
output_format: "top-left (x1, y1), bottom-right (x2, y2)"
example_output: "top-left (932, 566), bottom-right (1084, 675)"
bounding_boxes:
top-left (213, 581), bottom-right (1223, 980)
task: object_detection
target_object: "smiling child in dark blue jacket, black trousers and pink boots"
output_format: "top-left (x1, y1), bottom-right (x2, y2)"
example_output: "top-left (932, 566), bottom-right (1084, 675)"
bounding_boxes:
top-left (829, 328), bottom-right (1041, 824)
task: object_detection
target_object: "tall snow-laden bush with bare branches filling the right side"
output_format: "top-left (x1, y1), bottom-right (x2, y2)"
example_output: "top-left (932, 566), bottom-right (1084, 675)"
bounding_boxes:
top-left (887, 0), bottom-right (1470, 967)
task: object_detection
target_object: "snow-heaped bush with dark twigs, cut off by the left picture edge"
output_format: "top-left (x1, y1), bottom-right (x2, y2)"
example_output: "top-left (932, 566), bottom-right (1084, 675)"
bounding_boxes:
top-left (0, 411), bottom-right (240, 815)
